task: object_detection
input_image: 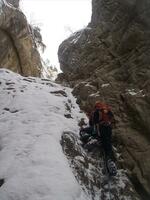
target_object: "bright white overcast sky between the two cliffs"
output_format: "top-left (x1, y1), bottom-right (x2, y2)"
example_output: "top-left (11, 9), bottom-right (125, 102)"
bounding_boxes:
top-left (21, 0), bottom-right (91, 70)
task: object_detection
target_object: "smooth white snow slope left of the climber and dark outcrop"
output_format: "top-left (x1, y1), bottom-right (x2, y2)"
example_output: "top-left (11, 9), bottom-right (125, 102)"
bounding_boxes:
top-left (0, 69), bottom-right (88, 200)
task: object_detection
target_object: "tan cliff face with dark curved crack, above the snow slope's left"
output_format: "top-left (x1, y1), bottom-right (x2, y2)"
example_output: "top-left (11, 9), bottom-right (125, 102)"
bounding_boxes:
top-left (0, 0), bottom-right (41, 76)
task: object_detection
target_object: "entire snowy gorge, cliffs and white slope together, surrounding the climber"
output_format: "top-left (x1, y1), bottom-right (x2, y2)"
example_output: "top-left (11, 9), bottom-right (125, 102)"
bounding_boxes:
top-left (0, 0), bottom-right (150, 200)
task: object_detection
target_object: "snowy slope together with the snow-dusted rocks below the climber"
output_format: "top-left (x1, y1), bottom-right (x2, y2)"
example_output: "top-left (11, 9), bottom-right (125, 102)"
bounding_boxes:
top-left (0, 69), bottom-right (140, 200)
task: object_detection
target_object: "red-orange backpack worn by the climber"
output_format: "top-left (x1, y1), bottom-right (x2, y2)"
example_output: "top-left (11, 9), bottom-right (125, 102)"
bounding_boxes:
top-left (95, 102), bottom-right (114, 125)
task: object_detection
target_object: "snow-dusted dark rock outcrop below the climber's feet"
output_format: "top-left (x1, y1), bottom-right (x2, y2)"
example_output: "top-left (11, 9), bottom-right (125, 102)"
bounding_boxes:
top-left (62, 132), bottom-right (140, 200)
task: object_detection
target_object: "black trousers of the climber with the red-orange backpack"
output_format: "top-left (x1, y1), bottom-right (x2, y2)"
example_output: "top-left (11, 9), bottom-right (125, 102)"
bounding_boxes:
top-left (100, 125), bottom-right (113, 159)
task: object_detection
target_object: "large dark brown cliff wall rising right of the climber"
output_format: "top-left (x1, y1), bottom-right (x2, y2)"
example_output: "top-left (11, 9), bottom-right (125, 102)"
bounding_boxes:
top-left (58, 0), bottom-right (150, 199)
